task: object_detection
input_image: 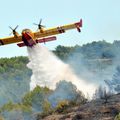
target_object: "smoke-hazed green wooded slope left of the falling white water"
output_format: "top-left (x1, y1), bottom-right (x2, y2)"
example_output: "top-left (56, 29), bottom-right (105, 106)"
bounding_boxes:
top-left (0, 56), bottom-right (32, 106)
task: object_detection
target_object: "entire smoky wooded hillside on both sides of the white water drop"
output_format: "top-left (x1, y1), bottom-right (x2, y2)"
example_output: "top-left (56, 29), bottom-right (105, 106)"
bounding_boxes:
top-left (0, 40), bottom-right (120, 120)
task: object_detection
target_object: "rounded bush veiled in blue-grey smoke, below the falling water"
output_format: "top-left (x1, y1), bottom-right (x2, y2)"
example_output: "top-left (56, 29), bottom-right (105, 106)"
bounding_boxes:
top-left (49, 80), bottom-right (85, 107)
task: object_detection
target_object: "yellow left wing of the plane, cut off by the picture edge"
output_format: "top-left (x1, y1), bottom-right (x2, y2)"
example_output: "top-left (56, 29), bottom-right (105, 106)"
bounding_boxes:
top-left (0, 35), bottom-right (22, 46)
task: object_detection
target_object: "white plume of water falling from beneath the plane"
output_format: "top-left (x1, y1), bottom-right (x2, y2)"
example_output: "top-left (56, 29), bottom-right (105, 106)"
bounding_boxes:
top-left (27, 45), bottom-right (97, 96)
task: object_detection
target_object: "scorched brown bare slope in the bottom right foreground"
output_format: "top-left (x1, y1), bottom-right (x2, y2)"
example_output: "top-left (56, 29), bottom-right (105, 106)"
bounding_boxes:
top-left (37, 94), bottom-right (120, 120)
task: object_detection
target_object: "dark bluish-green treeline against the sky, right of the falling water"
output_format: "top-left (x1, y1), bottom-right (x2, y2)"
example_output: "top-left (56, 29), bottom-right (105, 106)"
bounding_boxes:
top-left (53, 40), bottom-right (120, 60)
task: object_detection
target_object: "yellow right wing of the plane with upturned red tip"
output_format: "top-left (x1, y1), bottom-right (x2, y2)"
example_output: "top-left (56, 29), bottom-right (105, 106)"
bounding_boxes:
top-left (34, 19), bottom-right (82, 38)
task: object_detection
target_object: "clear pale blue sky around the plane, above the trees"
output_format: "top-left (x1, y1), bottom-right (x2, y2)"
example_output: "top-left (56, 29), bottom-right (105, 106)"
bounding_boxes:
top-left (0, 0), bottom-right (120, 58)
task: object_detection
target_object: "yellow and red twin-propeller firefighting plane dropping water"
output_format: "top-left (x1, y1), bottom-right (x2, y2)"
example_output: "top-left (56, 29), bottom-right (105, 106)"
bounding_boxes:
top-left (0, 19), bottom-right (82, 47)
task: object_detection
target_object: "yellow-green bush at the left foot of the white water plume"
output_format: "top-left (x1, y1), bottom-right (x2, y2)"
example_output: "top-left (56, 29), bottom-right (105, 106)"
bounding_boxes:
top-left (22, 86), bottom-right (51, 111)
